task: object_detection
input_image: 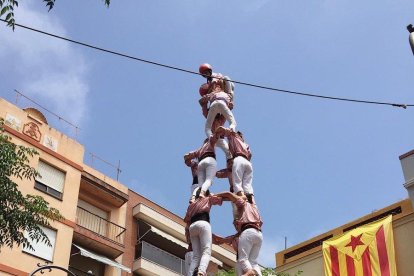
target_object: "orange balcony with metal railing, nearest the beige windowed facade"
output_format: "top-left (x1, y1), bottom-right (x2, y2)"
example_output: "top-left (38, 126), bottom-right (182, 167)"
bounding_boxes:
top-left (73, 206), bottom-right (126, 258)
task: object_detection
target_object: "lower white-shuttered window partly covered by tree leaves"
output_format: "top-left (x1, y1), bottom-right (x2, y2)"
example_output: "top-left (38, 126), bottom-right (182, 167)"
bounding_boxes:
top-left (23, 226), bottom-right (57, 262)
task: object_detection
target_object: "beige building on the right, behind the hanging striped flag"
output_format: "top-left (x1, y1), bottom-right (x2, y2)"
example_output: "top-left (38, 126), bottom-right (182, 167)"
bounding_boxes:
top-left (275, 151), bottom-right (414, 276)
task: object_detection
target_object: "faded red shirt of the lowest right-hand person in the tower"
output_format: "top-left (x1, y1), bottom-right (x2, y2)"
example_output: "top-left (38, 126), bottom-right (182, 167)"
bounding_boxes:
top-left (235, 198), bottom-right (263, 233)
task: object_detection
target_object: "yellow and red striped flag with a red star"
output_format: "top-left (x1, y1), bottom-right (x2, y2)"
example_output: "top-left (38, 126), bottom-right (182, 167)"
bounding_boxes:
top-left (322, 216), bottom-right (397, 276)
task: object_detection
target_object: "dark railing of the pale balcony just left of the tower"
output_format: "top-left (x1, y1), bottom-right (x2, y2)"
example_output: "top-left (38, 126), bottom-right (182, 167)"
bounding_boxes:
top-left (135, 241), bottom-right (184, 275)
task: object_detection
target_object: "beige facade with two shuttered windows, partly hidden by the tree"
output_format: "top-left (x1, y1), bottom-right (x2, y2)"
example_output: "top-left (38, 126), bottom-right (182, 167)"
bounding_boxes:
top-left (0, 99), bottom-right (84, 275)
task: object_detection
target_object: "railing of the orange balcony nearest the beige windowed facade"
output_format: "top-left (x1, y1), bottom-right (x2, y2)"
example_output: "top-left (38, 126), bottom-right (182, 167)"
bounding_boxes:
top-left (76, 206), bottom-right (125, 244)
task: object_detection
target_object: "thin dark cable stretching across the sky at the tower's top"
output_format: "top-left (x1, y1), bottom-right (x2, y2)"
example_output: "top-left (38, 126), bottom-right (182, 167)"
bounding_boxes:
top-left (0, 19), bottom-right (414, 109)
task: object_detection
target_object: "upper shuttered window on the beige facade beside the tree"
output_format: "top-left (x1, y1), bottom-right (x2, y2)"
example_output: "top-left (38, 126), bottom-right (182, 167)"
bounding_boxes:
top-left (35, 160), bottom-right (65, 199)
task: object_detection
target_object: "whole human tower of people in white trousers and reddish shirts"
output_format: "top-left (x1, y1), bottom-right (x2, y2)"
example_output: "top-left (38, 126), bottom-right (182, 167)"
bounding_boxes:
top-left (184, 63), bottom-right (263, 276)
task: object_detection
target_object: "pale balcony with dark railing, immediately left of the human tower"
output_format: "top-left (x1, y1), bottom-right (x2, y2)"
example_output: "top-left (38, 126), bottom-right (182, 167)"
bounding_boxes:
top-left (133, 241), bottom-right (184, 276)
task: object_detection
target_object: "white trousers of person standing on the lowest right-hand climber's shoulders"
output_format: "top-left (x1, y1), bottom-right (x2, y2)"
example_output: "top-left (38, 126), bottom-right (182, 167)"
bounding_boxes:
top-left (232, 156), bottom-right (253, 194)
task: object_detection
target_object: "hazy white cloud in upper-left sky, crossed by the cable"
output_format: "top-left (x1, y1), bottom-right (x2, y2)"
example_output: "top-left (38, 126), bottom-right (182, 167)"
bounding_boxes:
top-left (0, 0), bottom-right (89, 125)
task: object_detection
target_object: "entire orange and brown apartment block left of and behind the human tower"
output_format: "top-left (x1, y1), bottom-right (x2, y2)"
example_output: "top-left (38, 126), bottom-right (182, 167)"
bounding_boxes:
top-left (0, 98), bottom-right (236, 276)
